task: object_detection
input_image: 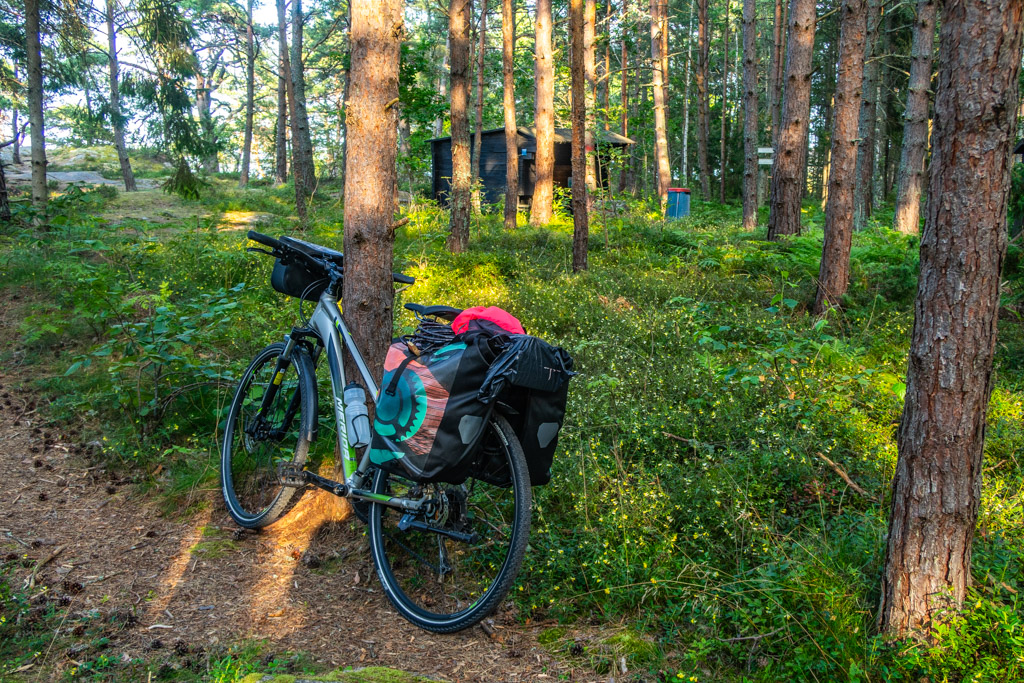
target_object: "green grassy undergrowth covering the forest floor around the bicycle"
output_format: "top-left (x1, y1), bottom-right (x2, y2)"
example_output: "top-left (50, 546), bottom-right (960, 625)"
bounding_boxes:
top-left (0, 180), bottom-right (1024, 681)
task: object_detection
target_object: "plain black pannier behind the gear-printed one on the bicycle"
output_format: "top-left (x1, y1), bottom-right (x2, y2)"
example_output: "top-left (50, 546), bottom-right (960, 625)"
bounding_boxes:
top-left (473, 335), bottom-right (575, 486)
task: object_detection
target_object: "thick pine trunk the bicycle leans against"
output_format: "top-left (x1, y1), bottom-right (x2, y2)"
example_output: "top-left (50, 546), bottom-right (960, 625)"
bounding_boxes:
top-left (343, 0), bottom-right (404, 379)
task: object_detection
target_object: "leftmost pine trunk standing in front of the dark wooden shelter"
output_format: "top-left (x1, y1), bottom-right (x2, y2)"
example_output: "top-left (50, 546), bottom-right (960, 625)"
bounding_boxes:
top-left (447, 0), bottom-right (473, 253)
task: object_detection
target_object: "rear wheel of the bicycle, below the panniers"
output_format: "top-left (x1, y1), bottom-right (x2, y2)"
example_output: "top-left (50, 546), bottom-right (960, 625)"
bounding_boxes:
top-left (370, 415), bottom-right (531, 633)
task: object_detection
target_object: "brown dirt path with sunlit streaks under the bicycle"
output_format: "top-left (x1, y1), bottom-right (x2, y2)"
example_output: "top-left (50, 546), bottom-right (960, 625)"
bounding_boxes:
top-left (0, 312), bottom-right (585, 682)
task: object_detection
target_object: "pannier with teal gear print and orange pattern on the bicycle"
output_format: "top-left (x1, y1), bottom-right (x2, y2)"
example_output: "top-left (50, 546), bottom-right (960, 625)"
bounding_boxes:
top-left (370, 334), bottom-right (500, 483)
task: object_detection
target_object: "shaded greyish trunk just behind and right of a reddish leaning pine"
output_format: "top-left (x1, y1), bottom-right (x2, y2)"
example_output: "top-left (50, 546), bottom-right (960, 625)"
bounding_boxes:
top-left (853, 0), bottom-right (882, 230)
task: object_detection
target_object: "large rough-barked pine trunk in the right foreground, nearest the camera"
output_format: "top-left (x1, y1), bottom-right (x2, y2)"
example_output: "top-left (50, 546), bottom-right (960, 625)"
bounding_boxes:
top-left (880, 0), bottom-right (1024, 636)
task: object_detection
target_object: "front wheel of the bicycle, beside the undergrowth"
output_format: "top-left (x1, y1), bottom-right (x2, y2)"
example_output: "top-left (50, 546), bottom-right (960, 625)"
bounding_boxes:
top-left (220, 343), bottom-right (316, 528)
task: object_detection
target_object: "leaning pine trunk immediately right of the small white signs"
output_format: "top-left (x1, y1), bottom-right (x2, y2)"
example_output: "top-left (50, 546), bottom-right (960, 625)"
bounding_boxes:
top-left (768, 0), bottom-right (817, 241)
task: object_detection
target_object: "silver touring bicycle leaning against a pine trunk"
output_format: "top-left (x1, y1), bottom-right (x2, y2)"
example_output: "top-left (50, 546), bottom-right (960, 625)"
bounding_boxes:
top-left (221, 231), bottom-right (531, 633)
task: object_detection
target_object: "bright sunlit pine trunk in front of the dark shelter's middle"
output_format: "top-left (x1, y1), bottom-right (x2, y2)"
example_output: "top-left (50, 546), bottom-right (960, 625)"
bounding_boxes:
top-left (529, 0), bottom-right (555, 225)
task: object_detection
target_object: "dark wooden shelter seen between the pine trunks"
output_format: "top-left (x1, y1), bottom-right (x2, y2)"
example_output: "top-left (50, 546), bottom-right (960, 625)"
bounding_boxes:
top-left (430, 126), bottom-right (633, 207)
